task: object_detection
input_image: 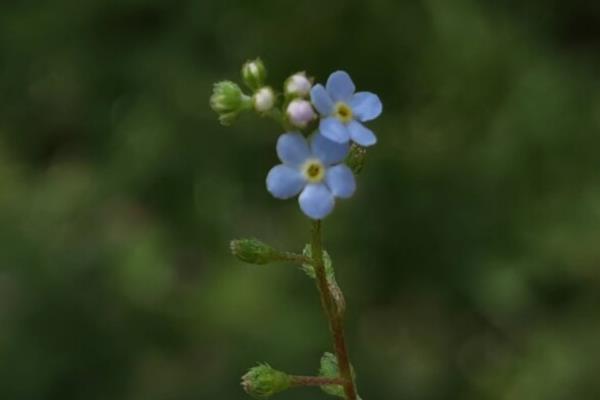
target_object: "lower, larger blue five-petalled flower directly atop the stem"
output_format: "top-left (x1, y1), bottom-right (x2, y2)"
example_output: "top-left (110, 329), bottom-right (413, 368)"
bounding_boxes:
top-left (267, 132), bottom-right (356, 219)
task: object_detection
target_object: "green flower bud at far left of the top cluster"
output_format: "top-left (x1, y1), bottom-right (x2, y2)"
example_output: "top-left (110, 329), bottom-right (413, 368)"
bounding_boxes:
top-left (210, 81), bottom-right (252, 125)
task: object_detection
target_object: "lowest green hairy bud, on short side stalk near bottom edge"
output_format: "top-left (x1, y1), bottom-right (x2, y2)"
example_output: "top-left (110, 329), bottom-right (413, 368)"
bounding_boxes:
top-left (242, 364), bottom-right (292, 399)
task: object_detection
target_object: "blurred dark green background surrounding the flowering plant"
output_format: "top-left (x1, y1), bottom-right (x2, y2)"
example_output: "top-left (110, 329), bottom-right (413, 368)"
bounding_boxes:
top-left (0, 0), bottom-right (600, 400)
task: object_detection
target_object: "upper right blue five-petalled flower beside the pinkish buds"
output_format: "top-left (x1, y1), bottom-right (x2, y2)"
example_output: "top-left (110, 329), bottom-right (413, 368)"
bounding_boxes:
top-left (310, 71), bottom-right (383, 146)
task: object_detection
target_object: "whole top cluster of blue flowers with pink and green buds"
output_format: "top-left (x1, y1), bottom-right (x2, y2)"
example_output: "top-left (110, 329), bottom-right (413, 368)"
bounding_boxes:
top-left (211, 59), bottom-right (382, 220)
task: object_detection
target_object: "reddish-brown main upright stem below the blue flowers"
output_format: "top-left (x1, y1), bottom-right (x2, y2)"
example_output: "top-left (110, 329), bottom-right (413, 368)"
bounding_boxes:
top-left (311, 221), bottom-right (357, 400)
